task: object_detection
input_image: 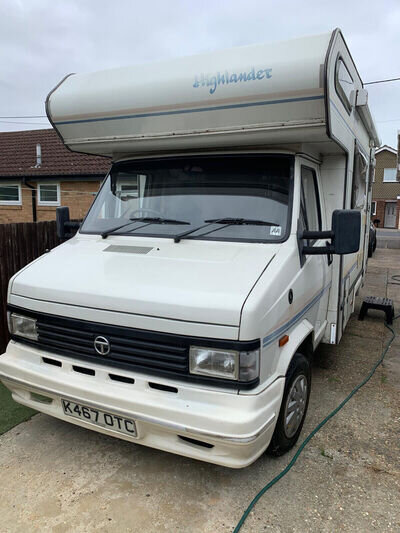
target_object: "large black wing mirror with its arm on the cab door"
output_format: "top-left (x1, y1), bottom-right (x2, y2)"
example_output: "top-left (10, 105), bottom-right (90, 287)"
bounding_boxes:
top-left (299, 209), bottom-right (361, 255)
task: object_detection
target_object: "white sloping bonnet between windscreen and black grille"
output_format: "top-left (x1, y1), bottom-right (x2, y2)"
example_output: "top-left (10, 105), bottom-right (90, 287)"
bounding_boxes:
top-left (11, 235), bottom-right (279, 327)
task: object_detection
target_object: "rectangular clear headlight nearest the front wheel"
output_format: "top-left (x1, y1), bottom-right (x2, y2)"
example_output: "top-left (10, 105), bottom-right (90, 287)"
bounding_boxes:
top-left (189, 346), bottom-right (260, 381)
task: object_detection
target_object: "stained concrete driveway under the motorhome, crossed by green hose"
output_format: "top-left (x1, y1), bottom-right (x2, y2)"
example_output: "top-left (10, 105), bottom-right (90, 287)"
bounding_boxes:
top-left (0, 249), bottom-right (400, 533)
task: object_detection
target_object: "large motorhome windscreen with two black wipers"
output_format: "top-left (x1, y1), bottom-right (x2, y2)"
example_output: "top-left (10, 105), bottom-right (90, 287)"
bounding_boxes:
top-left (81, 155), bottom-right (294, 242)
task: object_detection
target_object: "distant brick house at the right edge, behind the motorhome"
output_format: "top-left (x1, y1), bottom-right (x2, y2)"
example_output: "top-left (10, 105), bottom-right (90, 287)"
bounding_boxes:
top-left (371, 144), bottom-right (400, 228)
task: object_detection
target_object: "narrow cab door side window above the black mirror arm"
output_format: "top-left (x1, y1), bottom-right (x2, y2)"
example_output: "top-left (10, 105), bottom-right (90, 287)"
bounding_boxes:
top-left (300, 167), bottom-right (321, 244)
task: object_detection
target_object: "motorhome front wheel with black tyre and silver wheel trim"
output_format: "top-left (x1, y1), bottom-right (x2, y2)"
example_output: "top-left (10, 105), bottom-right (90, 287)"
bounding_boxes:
top-left (268, 353), bottom-right (311, 456)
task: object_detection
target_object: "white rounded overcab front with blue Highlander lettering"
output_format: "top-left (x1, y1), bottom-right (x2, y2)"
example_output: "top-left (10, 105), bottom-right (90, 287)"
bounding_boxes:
top-left (47, 34), bottom-right (331, 156)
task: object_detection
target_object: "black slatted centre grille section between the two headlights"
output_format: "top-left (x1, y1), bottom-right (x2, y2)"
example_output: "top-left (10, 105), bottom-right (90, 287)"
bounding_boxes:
top-left (37, 318), bottom-right (188, 374)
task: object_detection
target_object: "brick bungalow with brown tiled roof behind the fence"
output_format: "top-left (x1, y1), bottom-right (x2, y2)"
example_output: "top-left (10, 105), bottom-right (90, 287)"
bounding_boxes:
top-left (0, 129), bottom-right (110, 223)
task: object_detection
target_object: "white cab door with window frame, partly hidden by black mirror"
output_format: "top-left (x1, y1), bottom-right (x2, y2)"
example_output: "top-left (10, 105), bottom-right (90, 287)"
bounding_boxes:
top-left (299, 159), bottom-right (332, 343)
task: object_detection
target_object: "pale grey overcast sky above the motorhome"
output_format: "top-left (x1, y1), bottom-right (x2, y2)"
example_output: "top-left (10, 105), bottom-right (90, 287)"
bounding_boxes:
top-left (0, 0), bottom-right (400, 146)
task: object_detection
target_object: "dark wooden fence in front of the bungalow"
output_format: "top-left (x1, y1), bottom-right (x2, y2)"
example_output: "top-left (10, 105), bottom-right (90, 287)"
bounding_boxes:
top-left (0, 221), bottom-right (60, 354)
